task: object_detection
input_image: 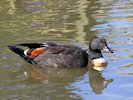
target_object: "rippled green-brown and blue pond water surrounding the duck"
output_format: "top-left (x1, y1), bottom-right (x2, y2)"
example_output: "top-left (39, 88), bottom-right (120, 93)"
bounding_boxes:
top-left (0, 0), bottom-right (133, 100)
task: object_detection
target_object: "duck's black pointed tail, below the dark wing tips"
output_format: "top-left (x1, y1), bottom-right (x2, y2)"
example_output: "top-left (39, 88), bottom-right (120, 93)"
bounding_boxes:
top-left (7, 45), bottom-right (36, 64)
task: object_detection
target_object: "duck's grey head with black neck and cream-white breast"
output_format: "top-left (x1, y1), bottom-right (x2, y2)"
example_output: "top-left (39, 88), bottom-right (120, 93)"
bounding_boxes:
top-left (89, 36), bottom-right (113, 71)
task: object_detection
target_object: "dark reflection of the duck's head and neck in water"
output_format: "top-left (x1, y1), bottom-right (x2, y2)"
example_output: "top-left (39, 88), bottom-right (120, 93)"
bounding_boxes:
top-left (88, 66), bottom-right (113, 94)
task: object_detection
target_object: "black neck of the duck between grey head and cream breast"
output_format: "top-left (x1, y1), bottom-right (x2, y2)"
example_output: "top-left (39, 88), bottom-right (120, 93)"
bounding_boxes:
top-left (89, 49), bottom-right (103, 60)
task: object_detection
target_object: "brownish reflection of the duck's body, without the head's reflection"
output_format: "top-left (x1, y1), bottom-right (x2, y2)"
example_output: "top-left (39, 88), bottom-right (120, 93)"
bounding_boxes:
top-left (23, 66), bottom-right (88, 85)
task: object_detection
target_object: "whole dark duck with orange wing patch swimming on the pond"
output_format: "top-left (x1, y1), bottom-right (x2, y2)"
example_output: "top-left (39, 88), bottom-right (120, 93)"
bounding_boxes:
top-left (8, 36), bottom-right (113, 68)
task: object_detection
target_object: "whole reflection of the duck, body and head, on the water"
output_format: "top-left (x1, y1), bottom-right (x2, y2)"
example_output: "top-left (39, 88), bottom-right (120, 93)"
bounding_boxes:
top-left (24, 61), bottom-right (113, 94)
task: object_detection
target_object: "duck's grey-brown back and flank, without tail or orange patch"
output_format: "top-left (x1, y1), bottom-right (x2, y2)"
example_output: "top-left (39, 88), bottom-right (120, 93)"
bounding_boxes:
top-left (34, 45), bottom-right (88, 67)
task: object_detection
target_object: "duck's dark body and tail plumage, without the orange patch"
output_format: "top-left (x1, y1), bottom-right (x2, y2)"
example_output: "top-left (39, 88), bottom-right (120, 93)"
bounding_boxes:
top-left (8, 42), bottom-right (88, 67)
